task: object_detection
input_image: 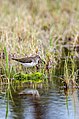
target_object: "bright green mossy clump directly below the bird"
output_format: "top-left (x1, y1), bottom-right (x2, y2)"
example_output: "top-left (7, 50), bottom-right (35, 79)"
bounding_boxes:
top-left (14, 72), bottom-right (45, 82)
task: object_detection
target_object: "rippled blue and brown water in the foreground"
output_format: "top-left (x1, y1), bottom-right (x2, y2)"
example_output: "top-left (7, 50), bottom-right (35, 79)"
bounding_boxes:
top-left (0, 84), bottom-right (79, 119)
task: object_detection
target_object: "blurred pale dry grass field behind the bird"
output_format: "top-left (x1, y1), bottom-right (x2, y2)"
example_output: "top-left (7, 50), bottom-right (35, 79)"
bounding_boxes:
top-left (0, 0), bottom-right (79, 65)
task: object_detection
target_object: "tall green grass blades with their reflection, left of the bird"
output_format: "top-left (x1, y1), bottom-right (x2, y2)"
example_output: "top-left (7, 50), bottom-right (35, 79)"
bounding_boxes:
top-left (4, 47), bottom-right (13, 119)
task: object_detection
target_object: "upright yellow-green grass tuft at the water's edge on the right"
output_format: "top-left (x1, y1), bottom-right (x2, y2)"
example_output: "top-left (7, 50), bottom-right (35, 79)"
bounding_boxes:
top-left (64, 54), bottom-right (77, 88)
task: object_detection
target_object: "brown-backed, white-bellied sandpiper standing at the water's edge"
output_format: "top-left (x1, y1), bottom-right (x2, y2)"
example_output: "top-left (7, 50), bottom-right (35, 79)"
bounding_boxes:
top-left (12, 55), bottom-right (45, 67)
